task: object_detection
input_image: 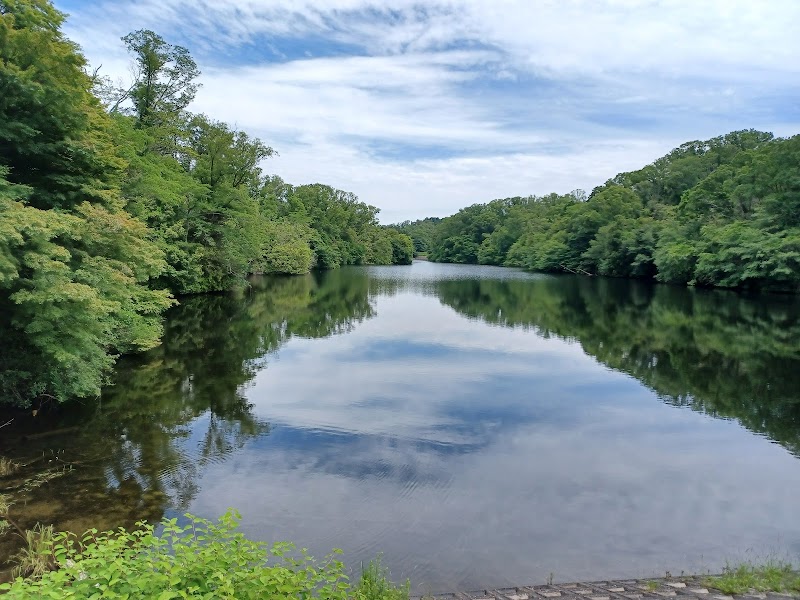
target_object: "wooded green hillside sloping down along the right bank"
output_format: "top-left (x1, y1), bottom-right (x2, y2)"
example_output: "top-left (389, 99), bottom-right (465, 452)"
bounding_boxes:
top-left (394, 130), bottom-right (800, 292)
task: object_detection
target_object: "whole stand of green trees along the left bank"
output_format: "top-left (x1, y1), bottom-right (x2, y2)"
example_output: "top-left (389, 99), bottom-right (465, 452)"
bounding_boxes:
top-left (0, 0), bottom-right (413, 406)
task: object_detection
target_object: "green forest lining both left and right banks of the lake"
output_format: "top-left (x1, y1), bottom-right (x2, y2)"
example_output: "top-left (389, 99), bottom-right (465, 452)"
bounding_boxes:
top-left (0, 0), bottom-right (800, 406)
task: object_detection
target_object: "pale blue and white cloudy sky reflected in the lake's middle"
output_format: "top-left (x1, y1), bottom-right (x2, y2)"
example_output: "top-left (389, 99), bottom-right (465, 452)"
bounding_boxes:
top-left (177, 263), bottom-right (800, 591)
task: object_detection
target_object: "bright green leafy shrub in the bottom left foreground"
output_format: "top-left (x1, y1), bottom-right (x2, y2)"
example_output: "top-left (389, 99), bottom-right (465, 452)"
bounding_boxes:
top-left (0, 510), bottom-right (408, 600)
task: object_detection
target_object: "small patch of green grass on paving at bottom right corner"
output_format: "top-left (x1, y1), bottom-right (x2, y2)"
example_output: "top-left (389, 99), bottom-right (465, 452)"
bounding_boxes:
top-left (704, 560), bottom-right (800, 594)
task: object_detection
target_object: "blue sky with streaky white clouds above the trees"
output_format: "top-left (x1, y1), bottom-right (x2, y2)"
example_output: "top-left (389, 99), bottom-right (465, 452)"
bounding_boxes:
top-left (54, 0), bottom-right (800, 223)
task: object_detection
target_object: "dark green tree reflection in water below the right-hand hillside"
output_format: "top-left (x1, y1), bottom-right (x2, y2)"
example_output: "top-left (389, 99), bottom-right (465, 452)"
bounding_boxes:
top-left (438, 277), bottom-right (800, 456)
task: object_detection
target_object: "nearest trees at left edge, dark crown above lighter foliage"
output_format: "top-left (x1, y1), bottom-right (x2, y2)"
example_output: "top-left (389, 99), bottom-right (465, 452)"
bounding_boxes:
top-left (0, 0), bottom-right (171, 405)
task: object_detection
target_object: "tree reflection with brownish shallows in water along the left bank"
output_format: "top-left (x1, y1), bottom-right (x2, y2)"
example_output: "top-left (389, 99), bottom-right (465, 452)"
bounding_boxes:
top-left (0, 272), bottom-right (374, 559)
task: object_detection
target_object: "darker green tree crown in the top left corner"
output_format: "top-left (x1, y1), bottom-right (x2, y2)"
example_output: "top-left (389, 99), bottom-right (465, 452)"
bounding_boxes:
top-left (0, 0), bottom-right (119, 209)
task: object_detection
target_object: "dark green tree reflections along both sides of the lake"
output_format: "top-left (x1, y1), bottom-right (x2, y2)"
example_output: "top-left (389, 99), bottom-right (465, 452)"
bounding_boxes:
top-left (6, 269), bottom-right (800, 572)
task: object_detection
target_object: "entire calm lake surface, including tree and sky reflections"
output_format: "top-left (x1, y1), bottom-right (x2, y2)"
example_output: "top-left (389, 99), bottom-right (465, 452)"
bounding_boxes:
top-left (0, 263), bottom-right (800, 591)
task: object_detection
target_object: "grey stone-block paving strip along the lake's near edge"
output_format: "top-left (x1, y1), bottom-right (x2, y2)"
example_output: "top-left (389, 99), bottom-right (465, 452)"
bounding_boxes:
top-left (416, 577), bottom-right (797, 600)
